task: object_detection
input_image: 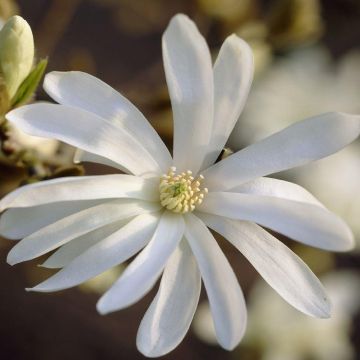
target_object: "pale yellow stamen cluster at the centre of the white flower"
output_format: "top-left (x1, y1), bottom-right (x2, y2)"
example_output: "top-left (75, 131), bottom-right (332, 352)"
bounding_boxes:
top-left (159, 167), bottom-right (208, 214)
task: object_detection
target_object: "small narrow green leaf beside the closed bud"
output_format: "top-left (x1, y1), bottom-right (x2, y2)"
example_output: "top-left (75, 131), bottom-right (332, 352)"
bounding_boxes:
top-left (11, 59), bottom-right (48, 108)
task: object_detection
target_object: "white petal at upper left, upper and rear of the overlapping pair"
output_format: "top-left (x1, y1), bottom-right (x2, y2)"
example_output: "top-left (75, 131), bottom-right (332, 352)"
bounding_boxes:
top-left (44, 71), bottom-right (172, 172)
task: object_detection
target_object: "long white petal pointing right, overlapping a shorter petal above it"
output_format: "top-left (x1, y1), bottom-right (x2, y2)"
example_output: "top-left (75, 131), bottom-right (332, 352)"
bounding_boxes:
top-left (197, 192), bottom-right (354, 251)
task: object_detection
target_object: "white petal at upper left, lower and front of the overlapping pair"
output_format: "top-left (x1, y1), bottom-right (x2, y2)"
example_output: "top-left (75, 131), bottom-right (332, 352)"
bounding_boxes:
top-left (6, 104), bottom-right (163, 175)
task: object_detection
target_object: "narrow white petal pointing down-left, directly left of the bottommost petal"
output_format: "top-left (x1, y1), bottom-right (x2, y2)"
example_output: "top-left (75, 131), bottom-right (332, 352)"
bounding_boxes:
top-left (97, 211), bottom-right (184, 314)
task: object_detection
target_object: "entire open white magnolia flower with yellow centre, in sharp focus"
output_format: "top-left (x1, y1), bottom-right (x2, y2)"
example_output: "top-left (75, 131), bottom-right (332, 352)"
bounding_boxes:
top-left (0, 15), bottom-right (360, 356)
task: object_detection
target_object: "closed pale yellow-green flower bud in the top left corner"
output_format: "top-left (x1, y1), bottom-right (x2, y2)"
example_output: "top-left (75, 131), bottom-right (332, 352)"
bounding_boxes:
top-left (0, 16), bottom-right (34, 99)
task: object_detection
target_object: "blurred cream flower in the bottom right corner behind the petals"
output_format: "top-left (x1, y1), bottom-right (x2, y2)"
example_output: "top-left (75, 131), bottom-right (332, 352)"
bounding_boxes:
top-left (193, 271), bottom-right (360, 360)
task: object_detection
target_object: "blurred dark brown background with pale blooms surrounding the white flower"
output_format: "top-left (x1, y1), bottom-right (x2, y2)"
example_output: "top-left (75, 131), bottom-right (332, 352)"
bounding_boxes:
top-left (0, 0), bottom-right (360, 360)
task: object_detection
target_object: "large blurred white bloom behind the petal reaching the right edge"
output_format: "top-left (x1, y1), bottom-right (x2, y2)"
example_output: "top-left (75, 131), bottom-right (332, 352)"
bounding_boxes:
top-left (228, 46), bottom-right (360, 248)
